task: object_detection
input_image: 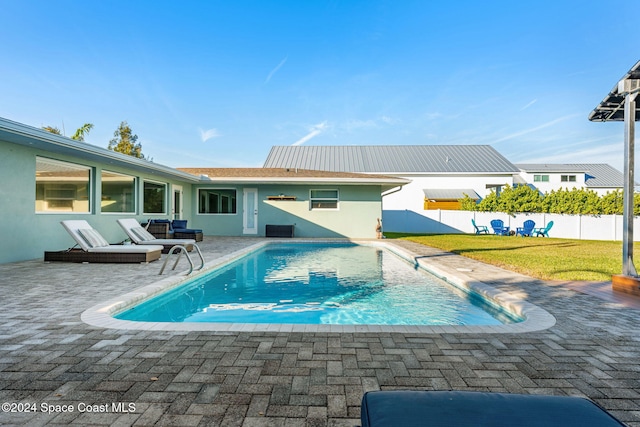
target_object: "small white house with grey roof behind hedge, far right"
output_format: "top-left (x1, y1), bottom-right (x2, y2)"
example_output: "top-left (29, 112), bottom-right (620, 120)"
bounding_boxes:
top-left (516, 163), bottom-right (624, 195)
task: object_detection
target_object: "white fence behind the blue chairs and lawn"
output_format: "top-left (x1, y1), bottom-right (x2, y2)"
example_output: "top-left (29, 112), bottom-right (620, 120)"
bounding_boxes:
top-left (382, 210), bottom-right (640, 241)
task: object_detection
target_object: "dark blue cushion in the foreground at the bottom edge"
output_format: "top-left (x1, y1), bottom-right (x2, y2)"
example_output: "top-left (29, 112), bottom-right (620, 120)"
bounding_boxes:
top-left (360, 390), bottom-right (624, 427)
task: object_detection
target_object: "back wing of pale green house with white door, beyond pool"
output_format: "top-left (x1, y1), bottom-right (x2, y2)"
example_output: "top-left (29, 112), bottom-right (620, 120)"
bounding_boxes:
top-left (180, 168), bottom-right (408, 238)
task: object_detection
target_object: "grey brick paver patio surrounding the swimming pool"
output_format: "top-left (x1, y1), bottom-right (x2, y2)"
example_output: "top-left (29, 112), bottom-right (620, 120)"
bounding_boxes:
top-left (0, 238), bottom-right (640, 427)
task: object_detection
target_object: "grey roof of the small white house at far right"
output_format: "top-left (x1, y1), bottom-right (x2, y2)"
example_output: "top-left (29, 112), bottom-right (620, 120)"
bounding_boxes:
top-left (516, 163), bottom-right (624, 188)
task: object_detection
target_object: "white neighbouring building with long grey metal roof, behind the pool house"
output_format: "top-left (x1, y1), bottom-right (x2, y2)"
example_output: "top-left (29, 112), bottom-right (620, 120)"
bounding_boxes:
top-left (264, 145), bottom-right (520, 231)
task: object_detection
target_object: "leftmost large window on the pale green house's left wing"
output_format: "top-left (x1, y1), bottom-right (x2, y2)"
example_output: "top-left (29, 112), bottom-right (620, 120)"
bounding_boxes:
top-left (36, 157), bottom-right (91, 213)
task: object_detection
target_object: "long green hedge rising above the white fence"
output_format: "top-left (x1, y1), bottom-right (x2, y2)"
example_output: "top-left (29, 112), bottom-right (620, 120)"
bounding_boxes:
top-left (460, 185), bottom-right (640, 215)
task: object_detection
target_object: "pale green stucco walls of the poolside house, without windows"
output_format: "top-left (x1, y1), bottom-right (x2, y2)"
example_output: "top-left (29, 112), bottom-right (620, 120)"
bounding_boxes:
top-left (0, 137), bottom-right (382, 263)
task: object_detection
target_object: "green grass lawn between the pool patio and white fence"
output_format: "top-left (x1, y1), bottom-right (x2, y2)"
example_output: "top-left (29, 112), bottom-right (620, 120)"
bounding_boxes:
top-left (385, 232), bottom-right (640, 281)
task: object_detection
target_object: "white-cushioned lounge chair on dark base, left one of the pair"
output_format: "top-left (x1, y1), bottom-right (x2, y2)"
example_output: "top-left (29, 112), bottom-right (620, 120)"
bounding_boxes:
top-left (45, 219), bottom-right (163, 263)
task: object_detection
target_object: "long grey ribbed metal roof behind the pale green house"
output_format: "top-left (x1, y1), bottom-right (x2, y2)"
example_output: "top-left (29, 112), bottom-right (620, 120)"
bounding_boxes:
top-left (264, 145), bottom-right (520, 174)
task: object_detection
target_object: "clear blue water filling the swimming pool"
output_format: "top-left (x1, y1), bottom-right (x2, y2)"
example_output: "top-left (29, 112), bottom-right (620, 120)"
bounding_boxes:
top-left (115, 243), bottom-right (520, 325)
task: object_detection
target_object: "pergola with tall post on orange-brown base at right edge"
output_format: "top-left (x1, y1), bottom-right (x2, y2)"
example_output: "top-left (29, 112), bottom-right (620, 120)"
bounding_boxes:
top-left (589, 61), bottom-right (640, 295)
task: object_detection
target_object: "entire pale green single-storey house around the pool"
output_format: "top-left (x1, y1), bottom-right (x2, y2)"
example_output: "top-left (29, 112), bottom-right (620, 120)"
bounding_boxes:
top-left (0, 118), bottom-right (407, 263)
